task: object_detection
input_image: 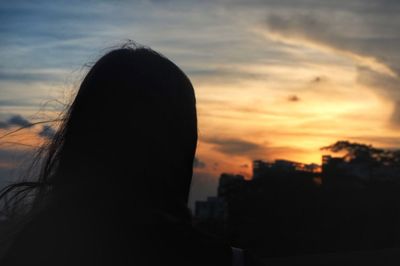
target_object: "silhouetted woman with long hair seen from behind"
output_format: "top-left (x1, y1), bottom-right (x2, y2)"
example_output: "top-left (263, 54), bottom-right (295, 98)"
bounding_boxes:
top-left (0, 47), bottom-right (247, 265)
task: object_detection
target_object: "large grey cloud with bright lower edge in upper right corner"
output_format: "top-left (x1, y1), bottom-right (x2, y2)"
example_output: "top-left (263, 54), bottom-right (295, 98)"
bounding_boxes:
top-left (265, 9), bottom-right (400, 125)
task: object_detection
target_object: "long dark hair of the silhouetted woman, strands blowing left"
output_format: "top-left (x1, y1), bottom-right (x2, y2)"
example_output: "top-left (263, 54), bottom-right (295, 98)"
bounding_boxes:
top-left (0, 45), bottom-right (197, 224)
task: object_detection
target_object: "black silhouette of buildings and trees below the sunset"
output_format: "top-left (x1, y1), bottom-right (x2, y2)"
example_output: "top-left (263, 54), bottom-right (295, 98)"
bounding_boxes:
top-left (196, 141), bottom-right (400, 257)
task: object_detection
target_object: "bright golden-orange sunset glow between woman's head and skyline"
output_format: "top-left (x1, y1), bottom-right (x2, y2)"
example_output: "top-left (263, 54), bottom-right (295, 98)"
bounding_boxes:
top-left (195, 38), bottom-right (399, 177)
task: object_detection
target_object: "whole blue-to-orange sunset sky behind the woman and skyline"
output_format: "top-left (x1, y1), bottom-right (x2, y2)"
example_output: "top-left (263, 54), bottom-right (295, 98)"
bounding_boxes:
top-left (0, 0), bottom-right (400, 206)
